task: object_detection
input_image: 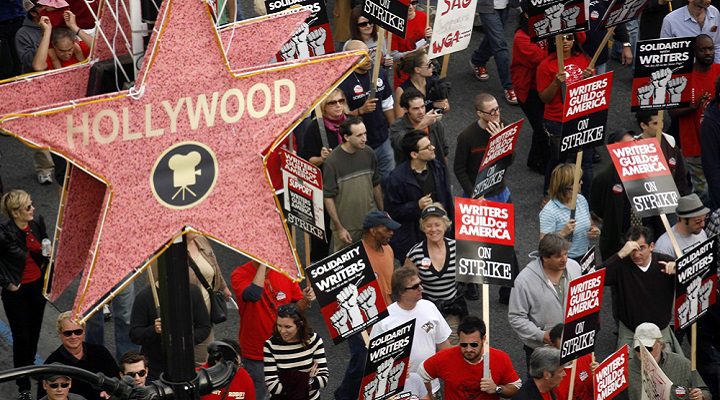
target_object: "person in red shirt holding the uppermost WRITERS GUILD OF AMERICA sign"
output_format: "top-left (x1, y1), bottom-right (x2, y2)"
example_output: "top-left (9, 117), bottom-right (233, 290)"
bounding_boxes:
top-left (536, 33), bottom-right (594, 197)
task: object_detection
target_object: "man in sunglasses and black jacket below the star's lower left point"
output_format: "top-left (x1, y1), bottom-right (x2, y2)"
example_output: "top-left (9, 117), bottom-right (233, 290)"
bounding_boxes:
top-left (38, 311), bottom-right (120, 400)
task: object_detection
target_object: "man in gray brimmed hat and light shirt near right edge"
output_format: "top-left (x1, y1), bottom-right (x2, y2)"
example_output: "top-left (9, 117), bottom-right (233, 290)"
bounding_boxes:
top-left (655, 193), bottom-right (710, 257)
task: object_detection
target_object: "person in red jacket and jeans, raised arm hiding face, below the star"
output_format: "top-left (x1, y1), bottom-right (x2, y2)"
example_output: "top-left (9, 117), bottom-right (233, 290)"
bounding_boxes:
top-left (230, 261), bottom-right (315, 399)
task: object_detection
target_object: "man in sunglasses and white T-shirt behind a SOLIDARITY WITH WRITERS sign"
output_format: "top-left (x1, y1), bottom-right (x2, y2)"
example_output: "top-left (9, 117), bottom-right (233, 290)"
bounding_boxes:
top-left (370, 267), bottom-right (452, 395)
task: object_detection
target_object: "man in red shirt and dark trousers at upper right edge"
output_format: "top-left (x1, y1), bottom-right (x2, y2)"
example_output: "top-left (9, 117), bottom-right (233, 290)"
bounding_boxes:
top-left (670, 34), bottom-right (720, 203)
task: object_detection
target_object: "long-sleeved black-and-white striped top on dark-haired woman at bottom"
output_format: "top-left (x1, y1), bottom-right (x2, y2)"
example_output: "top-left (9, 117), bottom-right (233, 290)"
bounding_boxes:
top-left (263, 333), bottom-right (328, 400)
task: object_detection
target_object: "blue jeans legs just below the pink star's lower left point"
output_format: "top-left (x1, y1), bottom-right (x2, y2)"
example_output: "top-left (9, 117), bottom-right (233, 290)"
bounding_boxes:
top-left (85, 283), bottom-right (139, 360)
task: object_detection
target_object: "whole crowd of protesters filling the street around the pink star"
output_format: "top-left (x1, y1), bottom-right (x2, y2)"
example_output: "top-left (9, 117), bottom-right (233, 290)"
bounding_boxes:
top-left (0, 0), bottom-right (720, 400)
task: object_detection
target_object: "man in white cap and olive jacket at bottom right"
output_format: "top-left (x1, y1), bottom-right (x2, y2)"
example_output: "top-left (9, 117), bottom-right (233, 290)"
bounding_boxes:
top-left (628, 322), bottom-right (711, 400)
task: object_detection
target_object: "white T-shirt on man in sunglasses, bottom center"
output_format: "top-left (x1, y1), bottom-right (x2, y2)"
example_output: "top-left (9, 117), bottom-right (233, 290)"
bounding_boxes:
top-left (370, 299), bottom-right (452, 393)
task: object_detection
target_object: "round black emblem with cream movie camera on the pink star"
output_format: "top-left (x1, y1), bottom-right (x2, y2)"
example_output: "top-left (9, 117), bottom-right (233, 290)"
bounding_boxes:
top-left (150, 142), bottom-right (218, 209)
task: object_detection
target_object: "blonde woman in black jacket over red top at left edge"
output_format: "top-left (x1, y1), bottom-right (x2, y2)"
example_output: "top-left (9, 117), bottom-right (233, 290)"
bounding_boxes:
top-left (0, 190), bottom-right (50, 400)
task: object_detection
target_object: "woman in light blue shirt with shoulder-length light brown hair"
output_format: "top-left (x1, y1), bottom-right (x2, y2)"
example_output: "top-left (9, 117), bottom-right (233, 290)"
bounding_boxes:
top-left (540, 164), bottom-right (600, 263)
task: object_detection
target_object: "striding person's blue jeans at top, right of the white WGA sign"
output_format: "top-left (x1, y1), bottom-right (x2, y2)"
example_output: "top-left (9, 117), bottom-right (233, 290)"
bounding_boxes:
top-left (470, 8), bottom-right (512, 89)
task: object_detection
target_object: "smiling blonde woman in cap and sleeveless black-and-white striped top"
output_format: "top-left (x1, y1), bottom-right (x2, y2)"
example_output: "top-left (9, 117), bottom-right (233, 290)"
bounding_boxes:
top-left (405, 202), bottom-right (468, 345)
